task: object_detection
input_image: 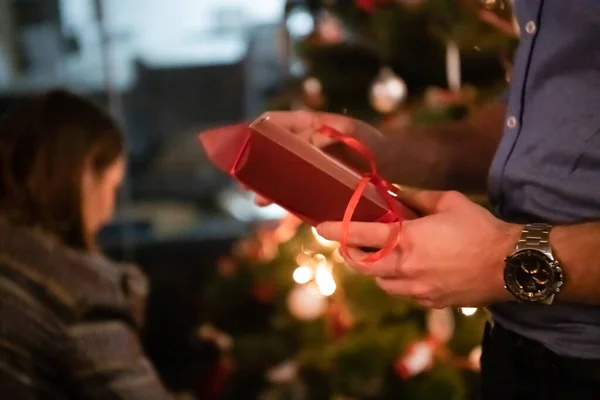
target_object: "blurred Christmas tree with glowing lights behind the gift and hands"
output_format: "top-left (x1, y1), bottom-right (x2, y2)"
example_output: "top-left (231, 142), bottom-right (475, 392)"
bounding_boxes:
top-left (196, 0), bottom-right (516, 400)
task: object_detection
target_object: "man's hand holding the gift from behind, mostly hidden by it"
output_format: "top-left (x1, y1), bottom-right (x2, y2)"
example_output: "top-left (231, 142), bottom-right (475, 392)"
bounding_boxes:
top-left (250, 111), bottom-right (384, 207)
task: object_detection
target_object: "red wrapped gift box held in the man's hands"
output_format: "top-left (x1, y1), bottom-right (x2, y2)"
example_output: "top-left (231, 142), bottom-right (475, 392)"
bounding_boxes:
top-left (199, 117), bottom-right (414, 262)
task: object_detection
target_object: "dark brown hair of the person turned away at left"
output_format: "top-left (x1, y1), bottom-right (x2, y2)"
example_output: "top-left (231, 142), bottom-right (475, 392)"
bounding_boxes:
top-left (0, 90), bottom-right (124, 250)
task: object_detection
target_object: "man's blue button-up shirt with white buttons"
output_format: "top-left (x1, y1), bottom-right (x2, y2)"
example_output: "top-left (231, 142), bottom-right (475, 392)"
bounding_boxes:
top-left (489, 0), bottom-right (600, 359)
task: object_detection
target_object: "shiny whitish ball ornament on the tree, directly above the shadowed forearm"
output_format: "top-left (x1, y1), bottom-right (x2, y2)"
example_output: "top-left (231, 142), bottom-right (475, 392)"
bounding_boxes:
top-left (369, 67), bottom-right (408, 114)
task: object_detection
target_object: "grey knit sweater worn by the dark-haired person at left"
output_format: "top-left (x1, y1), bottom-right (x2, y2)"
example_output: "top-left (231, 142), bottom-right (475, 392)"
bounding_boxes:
top-left (0, 222), bottom-right (171, 400)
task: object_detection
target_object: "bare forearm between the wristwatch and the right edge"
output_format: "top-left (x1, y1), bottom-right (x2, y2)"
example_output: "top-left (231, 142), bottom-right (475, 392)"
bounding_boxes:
top-left (550, 222), bottom-right (600, 305)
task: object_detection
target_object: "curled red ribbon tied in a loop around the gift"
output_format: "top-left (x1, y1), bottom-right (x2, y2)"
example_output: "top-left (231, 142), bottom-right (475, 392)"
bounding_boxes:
top-left (317, 125), bottom-right (402, 263)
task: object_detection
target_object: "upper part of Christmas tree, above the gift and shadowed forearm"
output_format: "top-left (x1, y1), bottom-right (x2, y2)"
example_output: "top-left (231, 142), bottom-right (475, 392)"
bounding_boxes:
top-left (273, 0), bottom-right (517, 123)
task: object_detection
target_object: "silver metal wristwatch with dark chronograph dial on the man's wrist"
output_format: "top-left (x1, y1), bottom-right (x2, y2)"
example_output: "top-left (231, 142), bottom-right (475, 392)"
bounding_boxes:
top-left (504, 224), bottom-right (564, 304)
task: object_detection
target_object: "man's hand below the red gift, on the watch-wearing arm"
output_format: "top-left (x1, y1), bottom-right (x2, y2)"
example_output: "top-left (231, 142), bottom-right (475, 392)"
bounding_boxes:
top-left (318, 191), bottom-right (521, 308)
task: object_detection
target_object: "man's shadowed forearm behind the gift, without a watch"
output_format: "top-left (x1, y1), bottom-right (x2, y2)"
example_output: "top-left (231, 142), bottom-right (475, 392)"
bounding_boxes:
top-left (371, 103), bottom-right (506, 193)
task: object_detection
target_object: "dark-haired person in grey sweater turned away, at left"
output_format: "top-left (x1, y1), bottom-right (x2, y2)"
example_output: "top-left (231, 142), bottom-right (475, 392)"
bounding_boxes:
top-left (0, 90), bottom-right (170, 399)
